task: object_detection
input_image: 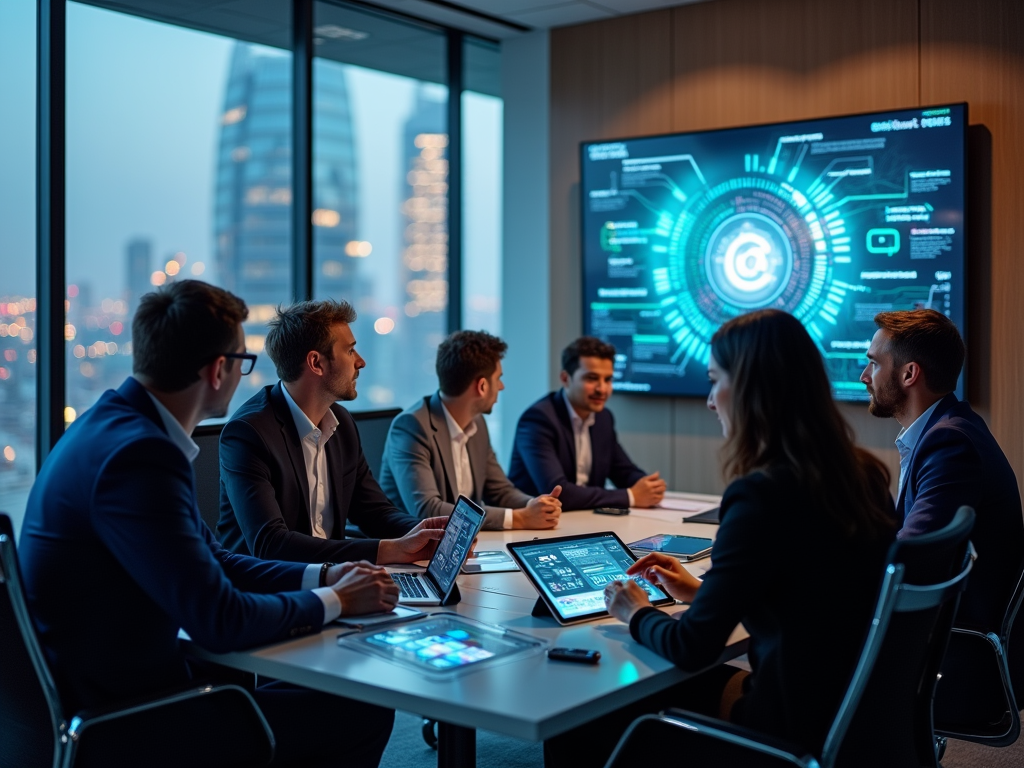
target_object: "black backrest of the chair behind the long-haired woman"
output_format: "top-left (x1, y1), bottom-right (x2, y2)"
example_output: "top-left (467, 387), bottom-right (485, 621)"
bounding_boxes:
top-left (821, 507), bottom-right (974, 767)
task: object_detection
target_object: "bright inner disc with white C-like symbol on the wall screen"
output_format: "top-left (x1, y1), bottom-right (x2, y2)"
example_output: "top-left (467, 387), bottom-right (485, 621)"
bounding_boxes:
top-left (703, 212), bottom-right (793, 307)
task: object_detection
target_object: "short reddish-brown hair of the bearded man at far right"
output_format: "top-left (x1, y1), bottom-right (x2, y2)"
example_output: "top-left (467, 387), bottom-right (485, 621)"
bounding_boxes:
top-left (874, 309), bottom-right (965, 394)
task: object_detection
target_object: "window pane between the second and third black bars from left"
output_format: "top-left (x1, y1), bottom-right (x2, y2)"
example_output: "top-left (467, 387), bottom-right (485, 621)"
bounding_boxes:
top-left (313, 4), bottom-right (447, 410)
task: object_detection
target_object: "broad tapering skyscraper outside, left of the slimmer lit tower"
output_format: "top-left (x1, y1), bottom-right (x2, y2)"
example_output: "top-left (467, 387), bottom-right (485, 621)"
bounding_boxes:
top-left (214, 43), bottom-right (361, 400)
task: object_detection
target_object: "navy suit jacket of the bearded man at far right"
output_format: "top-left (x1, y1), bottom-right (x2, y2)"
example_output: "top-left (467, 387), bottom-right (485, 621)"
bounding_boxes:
top-left (896, 394), bottom-right (1024, 632)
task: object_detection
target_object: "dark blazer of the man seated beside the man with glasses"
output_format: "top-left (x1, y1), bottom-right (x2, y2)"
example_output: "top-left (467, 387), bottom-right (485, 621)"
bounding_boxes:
top-left (217, 382), bottom-right (419, 563)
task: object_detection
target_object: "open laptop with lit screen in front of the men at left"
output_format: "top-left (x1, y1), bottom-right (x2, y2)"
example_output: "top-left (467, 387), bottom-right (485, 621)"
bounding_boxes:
top-left (388, 496), bottom-right (483, 605)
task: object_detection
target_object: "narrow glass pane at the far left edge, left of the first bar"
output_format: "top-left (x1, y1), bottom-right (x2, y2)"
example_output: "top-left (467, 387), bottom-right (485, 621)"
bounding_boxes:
top-left (0, 0), bottom-right (36, 536)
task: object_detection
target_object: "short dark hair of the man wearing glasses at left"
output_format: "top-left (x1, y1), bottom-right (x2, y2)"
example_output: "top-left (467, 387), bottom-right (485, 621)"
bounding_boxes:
top-left (131, 280), bottom-right (249, 392)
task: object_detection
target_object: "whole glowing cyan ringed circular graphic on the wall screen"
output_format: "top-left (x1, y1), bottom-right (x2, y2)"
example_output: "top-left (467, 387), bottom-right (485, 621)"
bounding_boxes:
top-left (652, 174), bottom-right (845, 371)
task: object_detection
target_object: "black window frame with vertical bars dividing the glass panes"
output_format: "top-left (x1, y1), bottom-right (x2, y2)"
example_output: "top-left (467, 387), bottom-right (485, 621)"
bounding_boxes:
top-left (36, 0), bottom-right (500, 472)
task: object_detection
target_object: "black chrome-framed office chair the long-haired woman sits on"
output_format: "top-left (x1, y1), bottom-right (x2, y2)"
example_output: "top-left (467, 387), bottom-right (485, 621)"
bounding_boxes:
top-left (606, 507), bottom-right (974, 768)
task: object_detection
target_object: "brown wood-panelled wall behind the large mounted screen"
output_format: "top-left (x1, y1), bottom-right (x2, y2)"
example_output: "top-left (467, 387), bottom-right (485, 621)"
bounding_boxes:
top-left (550, 0), bottom-right (1024, 492)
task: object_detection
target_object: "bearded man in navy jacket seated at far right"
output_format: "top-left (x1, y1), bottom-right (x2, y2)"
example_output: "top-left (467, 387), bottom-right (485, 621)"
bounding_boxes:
top-left (860, 309), bottom-right (1024, 724)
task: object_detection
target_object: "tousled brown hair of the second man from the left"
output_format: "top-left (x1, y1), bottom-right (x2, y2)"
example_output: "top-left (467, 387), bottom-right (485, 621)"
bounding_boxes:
top-left (264, 299), bottom-right (355, 382)
